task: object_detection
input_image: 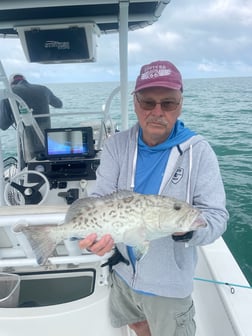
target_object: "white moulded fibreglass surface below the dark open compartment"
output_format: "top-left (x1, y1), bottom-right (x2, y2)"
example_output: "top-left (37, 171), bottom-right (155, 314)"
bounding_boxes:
top-left (0, 278), bottom-right (128, 336)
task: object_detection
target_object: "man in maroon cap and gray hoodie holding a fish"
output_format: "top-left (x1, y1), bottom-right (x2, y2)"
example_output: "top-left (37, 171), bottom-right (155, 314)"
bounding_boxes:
top-left (80, 61), bottom-right (228, 336)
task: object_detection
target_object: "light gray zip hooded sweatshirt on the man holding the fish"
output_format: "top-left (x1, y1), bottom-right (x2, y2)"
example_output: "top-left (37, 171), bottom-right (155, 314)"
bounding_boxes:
top-left (92, 124), bottom-right (228, 298)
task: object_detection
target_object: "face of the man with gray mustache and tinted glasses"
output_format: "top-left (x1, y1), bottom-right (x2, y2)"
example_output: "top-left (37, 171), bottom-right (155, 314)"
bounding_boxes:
top-left (134, 87), bottom-right (182, 146)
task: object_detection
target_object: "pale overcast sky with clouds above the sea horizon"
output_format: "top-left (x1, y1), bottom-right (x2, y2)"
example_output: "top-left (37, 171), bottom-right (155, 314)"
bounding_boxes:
top-left (0, 0), bottom-right (252, 83)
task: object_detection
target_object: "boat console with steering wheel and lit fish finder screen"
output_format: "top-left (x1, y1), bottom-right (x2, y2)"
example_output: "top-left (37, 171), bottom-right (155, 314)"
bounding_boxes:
top-left (5, 127), bottom-right (100, 205)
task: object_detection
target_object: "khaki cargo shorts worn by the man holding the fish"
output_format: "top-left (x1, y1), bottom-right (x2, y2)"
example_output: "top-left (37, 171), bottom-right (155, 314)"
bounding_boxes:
top-left (110, 272), bottom-right (196, 336)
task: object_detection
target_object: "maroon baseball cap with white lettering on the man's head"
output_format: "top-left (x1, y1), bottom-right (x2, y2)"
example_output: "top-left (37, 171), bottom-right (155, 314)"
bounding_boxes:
top-left (133, 61), bottom-right (183, 93)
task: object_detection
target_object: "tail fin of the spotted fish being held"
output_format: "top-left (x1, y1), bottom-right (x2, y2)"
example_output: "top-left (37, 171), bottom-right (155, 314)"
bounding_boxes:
top-left (14, 224), bottom-right (59, 265)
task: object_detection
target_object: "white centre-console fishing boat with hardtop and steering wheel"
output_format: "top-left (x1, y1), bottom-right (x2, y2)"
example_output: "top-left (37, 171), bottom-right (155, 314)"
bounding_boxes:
top-left (0, 0), bottom-right (252, 336)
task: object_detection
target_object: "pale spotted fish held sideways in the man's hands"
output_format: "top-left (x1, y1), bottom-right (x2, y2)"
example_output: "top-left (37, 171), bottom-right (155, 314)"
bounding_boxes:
top-left (13, 190), bottom-right (206, 265)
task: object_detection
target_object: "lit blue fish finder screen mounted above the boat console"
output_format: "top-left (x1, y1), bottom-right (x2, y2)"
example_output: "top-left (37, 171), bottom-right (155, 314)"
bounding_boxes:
top-left (45, 127), bottom-right (94, 158)
